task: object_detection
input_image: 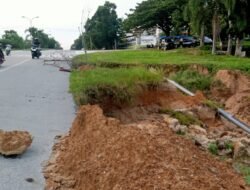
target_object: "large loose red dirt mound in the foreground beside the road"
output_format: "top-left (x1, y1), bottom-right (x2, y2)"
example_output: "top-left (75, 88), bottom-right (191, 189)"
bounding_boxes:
top-left (44, 105), bottom-right (247, 190)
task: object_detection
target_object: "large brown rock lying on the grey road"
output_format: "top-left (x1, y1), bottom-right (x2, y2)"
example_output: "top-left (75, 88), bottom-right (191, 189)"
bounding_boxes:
top-left (0, 130), bottom-right (32, 156)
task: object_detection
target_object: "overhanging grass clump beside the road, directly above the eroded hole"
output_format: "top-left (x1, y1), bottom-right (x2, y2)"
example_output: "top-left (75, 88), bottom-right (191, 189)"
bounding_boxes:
top-left (70, 67), bottom-right (163, 104)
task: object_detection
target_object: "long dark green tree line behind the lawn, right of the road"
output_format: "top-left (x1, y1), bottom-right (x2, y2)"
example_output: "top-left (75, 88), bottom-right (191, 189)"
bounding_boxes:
top-left (72, 0), bottom-right (250, 55)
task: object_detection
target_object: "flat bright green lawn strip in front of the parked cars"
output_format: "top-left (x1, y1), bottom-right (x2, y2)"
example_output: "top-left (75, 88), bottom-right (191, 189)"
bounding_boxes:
top-left (73, 48), bottom-right (250, 73)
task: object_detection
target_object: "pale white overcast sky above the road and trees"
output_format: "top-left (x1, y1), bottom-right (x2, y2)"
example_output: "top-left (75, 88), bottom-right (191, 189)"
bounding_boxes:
top-left (0, 0), bottom-right (143, 49)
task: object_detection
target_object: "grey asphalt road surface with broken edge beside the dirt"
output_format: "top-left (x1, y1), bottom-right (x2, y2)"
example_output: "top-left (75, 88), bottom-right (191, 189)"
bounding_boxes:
top-left (0, 51), bottom-right (75, 190)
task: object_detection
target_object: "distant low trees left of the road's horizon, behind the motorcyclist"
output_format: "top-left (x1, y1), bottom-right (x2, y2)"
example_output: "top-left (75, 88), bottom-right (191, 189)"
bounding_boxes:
top-left (0, 27), bottom-right (61, 49)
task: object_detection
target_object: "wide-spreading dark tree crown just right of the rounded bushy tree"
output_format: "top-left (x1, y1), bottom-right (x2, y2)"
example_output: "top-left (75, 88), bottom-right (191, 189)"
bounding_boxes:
top-left (124, 0), bottom-right (187, 35)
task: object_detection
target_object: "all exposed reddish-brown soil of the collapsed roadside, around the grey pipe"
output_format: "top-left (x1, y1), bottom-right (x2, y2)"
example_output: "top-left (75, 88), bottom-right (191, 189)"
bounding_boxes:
top-left (44, 68), bottom-right (250, 190)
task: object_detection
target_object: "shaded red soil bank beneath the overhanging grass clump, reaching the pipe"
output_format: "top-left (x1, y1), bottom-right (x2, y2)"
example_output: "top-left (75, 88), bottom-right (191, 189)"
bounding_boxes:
top-left (109, 83), bottom-right (205, 123)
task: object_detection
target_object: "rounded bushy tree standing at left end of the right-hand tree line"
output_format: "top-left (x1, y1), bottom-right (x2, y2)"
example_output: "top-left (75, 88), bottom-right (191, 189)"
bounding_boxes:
top-left (84, 1), bottom-right (119, 49)
